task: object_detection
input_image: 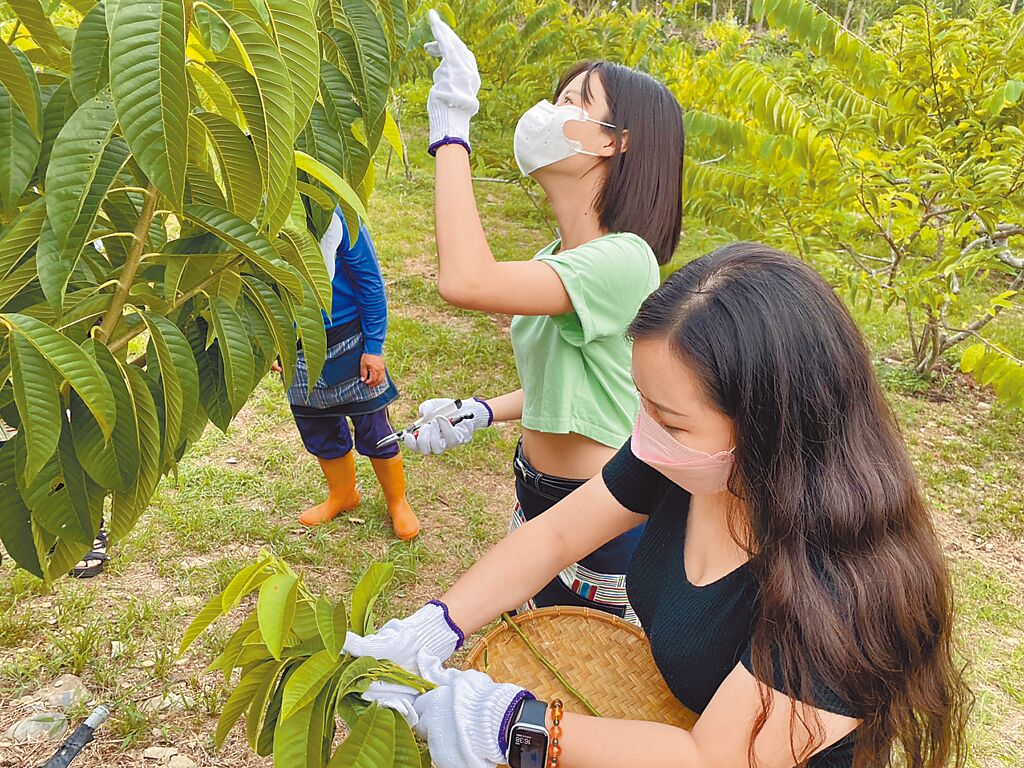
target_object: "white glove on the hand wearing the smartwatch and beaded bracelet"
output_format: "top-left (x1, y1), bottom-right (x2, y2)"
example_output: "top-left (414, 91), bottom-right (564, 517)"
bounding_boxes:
top-left (414, 659), bottom-right (534, 768)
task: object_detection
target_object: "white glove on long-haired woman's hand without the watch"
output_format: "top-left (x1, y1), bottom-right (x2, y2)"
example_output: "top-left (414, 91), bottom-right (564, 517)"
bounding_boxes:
top-left (344, 600), bottom-right (465, 675)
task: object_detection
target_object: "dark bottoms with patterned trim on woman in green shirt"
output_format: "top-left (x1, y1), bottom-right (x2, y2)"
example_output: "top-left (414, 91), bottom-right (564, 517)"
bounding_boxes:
top-left (509, 442), bottom-right (644, 624)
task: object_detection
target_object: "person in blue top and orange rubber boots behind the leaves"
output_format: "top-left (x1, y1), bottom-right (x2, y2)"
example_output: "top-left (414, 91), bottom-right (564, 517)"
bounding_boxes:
top-left (288, 210), bottom-right (420, 540)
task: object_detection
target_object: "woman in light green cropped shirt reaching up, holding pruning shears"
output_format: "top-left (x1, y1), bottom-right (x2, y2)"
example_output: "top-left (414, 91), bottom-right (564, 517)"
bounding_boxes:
top-left (407, 11), bottom-right (683, 622)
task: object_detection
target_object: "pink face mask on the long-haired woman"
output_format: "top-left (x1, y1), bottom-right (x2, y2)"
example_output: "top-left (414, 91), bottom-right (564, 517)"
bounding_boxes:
top-left (632, 406), bottom-right (733, 496)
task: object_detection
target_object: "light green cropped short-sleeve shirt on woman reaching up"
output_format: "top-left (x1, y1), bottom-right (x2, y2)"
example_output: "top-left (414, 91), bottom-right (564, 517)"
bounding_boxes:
top-left (511, 232), bottom-right (659, 447)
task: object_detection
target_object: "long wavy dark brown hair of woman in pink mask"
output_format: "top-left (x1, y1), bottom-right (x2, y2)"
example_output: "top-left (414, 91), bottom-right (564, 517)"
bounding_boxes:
top-left (631, 243), bottom-right (972, 768)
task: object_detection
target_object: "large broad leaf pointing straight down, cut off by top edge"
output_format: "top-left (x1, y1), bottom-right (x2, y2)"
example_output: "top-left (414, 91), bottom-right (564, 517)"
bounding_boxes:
top-left (106, 0), bottom-right (188, 210)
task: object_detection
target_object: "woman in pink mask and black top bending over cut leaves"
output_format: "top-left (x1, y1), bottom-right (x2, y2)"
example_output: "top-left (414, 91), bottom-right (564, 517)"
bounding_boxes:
top-left (342, 243), bottom-right (970, 768)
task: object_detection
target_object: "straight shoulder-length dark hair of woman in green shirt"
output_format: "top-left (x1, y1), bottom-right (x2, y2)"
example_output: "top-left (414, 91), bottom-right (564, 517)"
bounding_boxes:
top-left (555, 61), bottom-right (684, 264)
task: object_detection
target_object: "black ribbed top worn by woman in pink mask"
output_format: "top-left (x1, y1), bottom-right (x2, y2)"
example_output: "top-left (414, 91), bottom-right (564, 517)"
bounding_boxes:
top-left (602, 441), bottom-right (858, 768)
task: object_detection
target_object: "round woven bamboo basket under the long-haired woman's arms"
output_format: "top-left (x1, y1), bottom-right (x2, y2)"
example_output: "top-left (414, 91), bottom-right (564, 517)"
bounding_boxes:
top-left (464, 606), bottom-right (697, 729)
